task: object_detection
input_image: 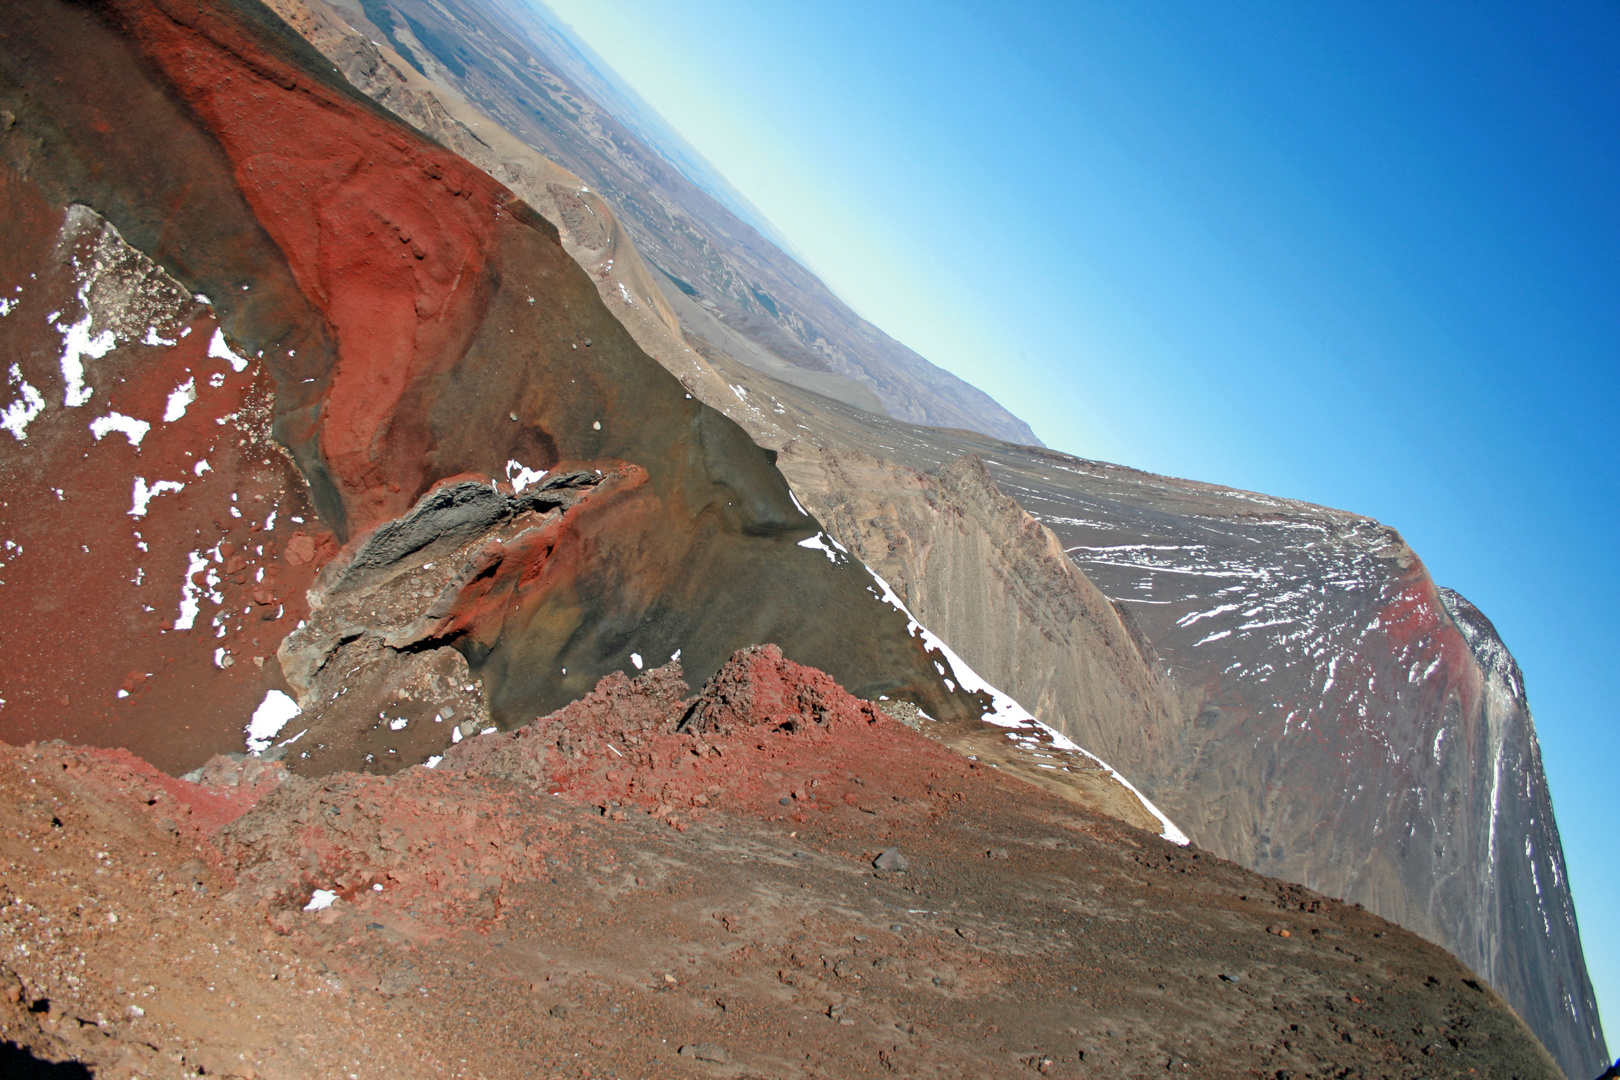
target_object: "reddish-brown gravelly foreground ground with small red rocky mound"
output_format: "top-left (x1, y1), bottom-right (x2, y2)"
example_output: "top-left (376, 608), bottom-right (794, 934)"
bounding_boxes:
top-left (0, 649), bottom-right (1560, 1078)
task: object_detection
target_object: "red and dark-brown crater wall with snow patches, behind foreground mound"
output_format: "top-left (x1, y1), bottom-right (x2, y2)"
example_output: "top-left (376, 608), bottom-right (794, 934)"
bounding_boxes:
top-left (0, 0), bottom-right (980, 771)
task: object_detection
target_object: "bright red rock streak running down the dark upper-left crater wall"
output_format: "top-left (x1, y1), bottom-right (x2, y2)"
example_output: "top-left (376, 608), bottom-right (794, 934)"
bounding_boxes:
top-left (109, 0), bottom-right (512, 531)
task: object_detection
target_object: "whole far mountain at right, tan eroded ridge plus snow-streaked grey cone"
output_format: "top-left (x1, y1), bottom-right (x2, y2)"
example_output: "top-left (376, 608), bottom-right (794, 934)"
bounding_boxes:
top-left (693, 372), bottom-right (1607, 1077)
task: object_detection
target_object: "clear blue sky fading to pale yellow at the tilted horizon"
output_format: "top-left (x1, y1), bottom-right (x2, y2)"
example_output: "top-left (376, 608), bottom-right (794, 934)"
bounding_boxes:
top-left (537, 0), bottom-right (1620, 1048)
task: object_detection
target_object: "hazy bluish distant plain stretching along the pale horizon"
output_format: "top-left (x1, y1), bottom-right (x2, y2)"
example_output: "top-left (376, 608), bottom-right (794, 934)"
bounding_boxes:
top-left (294, 0), bottom-right (1038, 444)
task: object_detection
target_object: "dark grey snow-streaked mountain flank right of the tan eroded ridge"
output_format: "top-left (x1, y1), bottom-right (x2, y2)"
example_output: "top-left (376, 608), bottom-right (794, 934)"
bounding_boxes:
top-left (1040, 470), bottom-right (1607, 1075)
